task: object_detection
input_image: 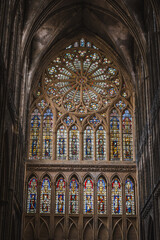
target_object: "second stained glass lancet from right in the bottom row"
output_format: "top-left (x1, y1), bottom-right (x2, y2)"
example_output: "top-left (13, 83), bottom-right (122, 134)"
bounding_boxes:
top-left (112, 177), bottom-right (122, 214)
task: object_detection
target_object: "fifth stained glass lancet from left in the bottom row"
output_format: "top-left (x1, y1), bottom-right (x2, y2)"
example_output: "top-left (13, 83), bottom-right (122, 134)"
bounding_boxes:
top-left (84, 177), bottom-right (94, 214)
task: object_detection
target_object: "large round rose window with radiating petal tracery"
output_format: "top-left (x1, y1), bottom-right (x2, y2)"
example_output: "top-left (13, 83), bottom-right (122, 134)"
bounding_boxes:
top-left (44, 39), bottom-right (120, 113)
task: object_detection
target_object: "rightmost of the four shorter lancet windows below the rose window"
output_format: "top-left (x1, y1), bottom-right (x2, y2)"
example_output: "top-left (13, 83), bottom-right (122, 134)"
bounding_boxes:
top-left (96, 126), bottom-right (106, 160)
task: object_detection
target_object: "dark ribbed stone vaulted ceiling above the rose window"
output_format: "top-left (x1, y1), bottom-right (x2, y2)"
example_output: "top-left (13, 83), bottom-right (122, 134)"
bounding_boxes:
top-left (22, 0), bottom-right (146, 90)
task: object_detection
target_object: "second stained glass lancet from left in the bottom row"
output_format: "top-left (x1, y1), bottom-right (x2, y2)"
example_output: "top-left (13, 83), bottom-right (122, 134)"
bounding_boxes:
top-left (40, 177), bottom-right (51, 213)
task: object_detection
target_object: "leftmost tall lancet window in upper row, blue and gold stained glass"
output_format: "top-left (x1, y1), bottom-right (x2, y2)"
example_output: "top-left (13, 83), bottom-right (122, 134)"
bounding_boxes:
top-left (29, 109), bottom-right (41, 159)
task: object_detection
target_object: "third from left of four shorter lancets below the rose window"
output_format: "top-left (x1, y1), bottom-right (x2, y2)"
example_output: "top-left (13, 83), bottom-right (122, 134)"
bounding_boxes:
top-left (84, 126), bottom-right (94, 160)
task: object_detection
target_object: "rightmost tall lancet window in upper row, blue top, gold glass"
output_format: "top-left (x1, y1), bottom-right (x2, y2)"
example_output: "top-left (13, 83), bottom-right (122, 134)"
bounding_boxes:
top-left (122, 110), bottom-right (133, 161)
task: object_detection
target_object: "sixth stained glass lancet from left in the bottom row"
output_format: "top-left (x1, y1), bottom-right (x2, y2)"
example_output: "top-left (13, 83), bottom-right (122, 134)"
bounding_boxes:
top-left (97, 177), bottom-right (107, 214)
